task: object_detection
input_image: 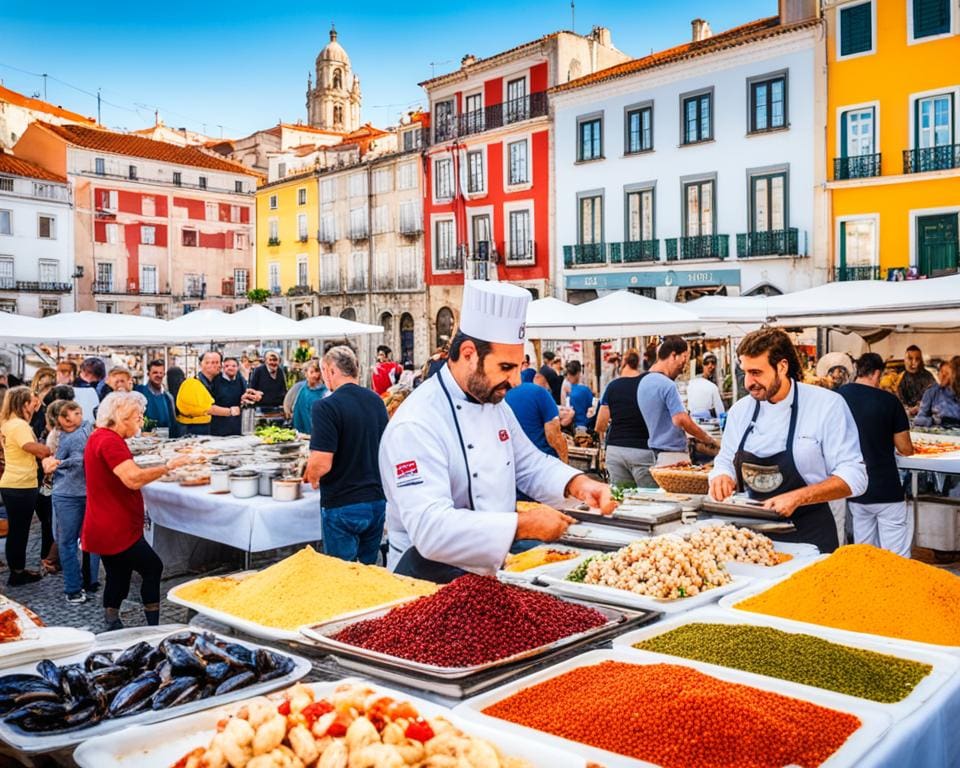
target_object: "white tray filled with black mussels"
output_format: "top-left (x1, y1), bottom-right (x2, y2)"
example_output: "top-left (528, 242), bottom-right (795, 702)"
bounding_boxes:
top-left (0, 625), bottom-right (310, 752)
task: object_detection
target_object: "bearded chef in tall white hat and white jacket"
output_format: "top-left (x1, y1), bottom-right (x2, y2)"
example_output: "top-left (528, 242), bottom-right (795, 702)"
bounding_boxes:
top-left (380, 281), bottom-right (616, 583)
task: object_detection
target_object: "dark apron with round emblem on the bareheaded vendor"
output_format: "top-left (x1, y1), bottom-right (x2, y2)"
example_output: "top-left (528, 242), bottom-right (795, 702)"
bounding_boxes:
top-left (733, 382), bottom-right (839, 554)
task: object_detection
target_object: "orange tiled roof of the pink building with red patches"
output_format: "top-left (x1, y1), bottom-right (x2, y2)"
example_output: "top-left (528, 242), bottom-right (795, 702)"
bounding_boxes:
top-left (37, 122), bottom-right (263, 176)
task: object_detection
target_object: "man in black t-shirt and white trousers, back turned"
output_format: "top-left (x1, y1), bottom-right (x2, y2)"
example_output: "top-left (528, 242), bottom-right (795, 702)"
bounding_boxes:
top-left (838, 352), bottom-right (913, 557)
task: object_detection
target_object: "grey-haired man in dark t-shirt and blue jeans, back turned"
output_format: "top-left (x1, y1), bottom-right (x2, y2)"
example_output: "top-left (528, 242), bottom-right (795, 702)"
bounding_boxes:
top-left (304, 346), bottom-right (387, 565)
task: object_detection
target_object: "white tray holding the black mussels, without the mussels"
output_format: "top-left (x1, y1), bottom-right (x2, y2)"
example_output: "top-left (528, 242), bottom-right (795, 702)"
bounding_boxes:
top-left (0, 625), bottom-right (311, 752)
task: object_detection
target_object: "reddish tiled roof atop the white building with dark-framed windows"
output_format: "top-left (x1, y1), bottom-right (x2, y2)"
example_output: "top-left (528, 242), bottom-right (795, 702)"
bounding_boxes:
top-left (550, 16), bottom-right (820, 93)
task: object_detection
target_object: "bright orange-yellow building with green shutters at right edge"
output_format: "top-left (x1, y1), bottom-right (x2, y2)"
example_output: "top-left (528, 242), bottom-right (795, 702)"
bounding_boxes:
top-left (824, 0), bottom-right (960, 280)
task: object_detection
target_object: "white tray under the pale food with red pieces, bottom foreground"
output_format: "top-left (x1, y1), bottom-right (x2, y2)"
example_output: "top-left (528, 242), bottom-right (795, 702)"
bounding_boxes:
top-left (73, 678), bottom-right (585, 768)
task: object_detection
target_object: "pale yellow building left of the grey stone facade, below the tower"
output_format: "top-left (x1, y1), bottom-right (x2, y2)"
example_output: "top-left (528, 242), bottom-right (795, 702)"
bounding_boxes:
top-left (256, 171), bottom-right (320, 296)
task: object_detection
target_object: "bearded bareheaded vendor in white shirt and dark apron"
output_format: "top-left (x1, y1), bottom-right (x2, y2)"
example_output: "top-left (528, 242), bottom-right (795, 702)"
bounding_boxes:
top-left (710, 328), bottom-right (867, 552)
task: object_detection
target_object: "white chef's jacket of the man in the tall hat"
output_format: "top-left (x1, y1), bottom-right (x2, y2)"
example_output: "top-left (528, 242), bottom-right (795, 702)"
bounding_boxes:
top-left (380, 365), bottom-right (580, 574)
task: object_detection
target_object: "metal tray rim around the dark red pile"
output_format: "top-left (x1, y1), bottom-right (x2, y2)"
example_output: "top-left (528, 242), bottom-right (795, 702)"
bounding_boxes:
top-left (300, 597), bottom-right (627, 680)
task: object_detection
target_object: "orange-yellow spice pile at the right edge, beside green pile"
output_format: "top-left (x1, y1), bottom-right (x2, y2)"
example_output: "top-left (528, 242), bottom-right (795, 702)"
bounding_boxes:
top-left (735, 544), bottom-right (960, 645)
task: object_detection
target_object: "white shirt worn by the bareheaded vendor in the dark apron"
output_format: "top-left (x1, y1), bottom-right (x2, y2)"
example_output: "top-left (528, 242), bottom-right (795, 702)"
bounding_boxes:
top-left (710, 381), bottom-right (867, 496)
